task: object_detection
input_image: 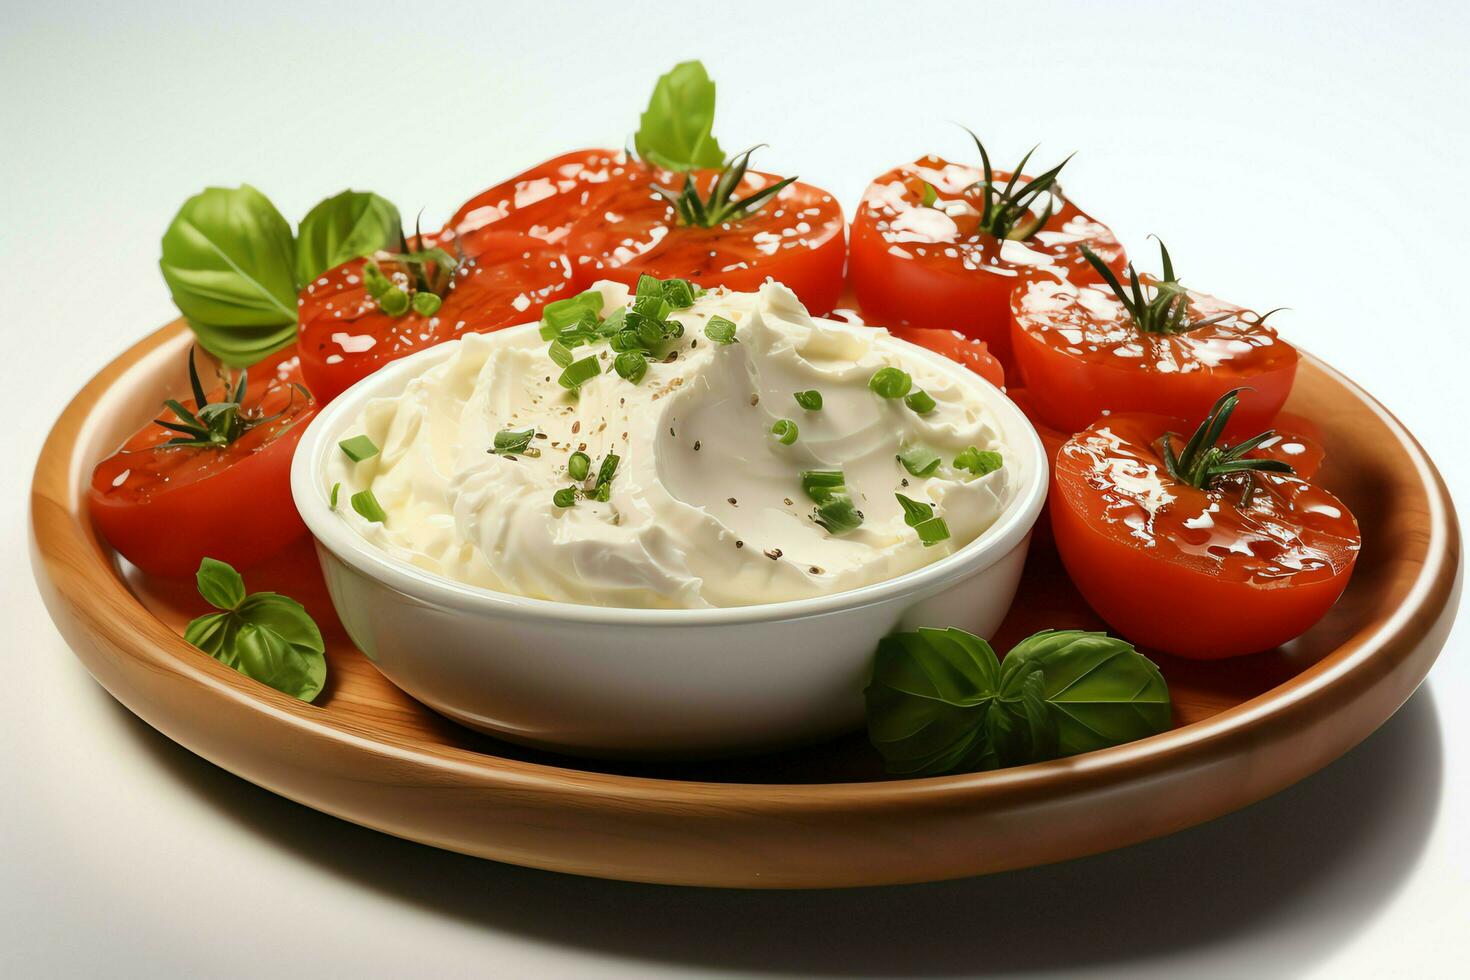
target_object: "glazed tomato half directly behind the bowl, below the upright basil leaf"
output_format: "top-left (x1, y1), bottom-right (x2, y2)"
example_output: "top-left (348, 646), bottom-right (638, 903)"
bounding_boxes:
top-left (566, 170), bottom-right (847, 316)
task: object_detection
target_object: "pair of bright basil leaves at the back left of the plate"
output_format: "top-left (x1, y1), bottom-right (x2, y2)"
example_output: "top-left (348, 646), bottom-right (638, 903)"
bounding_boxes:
top-left (159, 184), bottom-right (403, 367)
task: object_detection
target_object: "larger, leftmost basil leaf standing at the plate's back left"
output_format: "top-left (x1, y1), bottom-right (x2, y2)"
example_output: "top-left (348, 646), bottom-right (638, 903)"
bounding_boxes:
top-left (159, 184), bottom-right (295, 366)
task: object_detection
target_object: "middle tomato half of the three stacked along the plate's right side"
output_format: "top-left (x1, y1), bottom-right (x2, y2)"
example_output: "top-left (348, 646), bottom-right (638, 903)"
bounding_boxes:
top-left (1010, 274), bottom-right (1299, 435)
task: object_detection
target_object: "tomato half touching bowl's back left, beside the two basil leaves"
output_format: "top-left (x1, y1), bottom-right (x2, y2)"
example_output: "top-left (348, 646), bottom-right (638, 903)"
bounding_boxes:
top-left (297, 229), bottom-right (572, 403)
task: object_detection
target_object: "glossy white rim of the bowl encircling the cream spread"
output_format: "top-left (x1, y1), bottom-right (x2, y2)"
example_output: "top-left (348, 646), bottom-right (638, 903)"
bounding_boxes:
top-left (291, 317), bottom-right (1051, 626)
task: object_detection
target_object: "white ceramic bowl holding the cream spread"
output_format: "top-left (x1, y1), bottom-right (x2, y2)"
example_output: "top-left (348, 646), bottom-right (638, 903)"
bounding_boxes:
top-left (291, 325), bottom-right (1047, 757)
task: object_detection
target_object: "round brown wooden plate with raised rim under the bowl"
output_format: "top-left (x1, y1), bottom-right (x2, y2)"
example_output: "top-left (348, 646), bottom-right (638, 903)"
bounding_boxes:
top-left (31, 322), bottom-right (1460, 887)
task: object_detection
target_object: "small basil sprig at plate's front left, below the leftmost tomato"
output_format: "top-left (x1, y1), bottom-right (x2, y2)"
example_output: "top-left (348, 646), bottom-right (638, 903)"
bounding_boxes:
top-left (184, 558), bottom-right (326, 701)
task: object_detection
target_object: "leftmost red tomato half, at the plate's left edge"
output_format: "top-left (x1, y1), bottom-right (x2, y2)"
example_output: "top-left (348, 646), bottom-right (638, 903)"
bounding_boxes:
top-left (88, 348), bottom-right (316, 577)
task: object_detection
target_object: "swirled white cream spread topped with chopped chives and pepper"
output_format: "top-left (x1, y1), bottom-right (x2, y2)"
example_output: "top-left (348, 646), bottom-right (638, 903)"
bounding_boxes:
top-left (328, 284), bottom-right (1014, 608)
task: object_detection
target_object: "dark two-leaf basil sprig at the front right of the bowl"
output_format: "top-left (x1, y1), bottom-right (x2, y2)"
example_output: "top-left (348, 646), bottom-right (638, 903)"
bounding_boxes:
top-left (866, 629), bottom-right (1172, 776)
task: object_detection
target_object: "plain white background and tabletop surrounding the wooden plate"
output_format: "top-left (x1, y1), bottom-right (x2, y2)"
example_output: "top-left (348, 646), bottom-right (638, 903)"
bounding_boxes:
top-left (0, 0), bottom-right (1470, 977)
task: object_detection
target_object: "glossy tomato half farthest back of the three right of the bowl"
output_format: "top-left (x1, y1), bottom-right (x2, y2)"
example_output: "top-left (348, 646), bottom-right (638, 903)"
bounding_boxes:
top-left (848, 156), bottom-right (1127, 367)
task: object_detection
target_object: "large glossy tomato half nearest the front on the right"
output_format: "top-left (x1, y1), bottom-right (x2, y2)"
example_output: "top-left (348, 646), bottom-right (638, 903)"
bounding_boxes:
top-left (1051, 414), bottom-right (1361, 660)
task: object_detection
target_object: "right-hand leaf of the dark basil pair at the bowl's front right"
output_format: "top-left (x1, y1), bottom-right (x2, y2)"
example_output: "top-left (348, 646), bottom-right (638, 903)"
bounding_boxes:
top-left (1000, 630), bottom-right (1173, 758)
